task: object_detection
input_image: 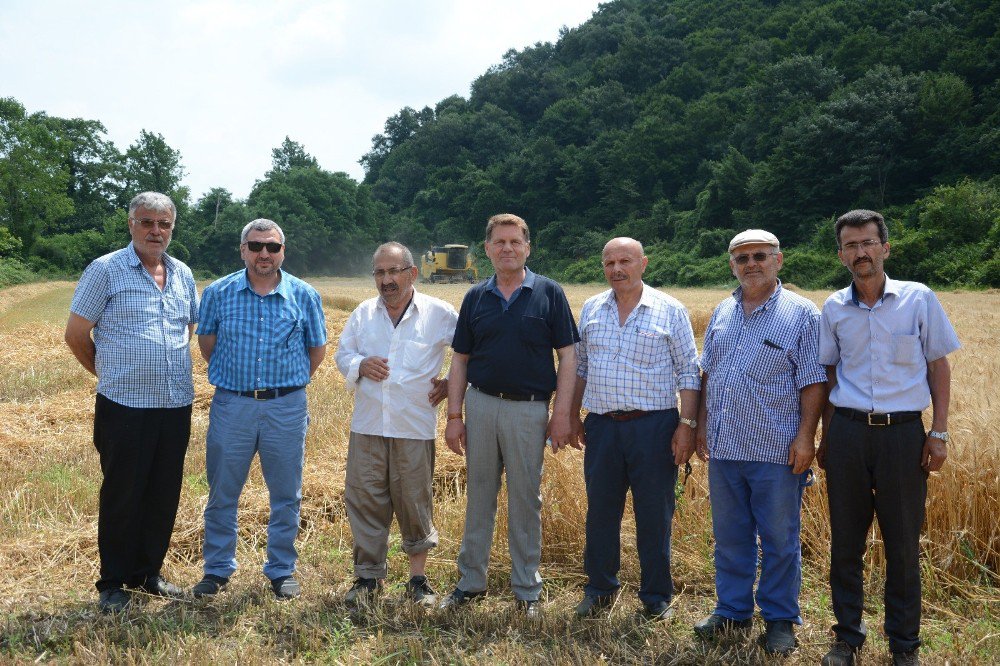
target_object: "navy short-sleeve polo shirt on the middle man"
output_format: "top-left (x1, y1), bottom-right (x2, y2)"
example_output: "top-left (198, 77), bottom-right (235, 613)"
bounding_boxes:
top-left (451, 269), bottom-right (580, 394)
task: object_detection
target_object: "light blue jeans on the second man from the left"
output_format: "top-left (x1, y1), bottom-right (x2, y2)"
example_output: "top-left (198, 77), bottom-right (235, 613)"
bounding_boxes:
top-left (205, 389), bottom-right (309, 580)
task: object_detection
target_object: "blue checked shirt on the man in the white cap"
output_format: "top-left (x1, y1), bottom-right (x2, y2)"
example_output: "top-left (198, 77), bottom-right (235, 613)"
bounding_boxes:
top-left (701, 281), bottom-right (826, 465)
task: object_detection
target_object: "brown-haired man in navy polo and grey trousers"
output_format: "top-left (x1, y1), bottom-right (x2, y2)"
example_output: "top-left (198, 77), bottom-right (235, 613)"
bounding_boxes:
top-left (441, 213), bottom-right (580, 618)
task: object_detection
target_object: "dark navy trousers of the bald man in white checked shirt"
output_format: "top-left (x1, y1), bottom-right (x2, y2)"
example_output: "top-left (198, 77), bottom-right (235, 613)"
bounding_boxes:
top-left (583, 409), bottom-right (677, 606)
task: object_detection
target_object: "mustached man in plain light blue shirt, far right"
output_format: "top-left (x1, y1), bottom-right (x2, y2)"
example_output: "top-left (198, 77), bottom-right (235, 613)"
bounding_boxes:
top-left (817, 210), bottom-right (960, 666)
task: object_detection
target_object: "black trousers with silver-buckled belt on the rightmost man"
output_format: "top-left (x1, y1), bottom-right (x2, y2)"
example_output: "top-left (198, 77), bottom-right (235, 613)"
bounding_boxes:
top-left (826, 414), bottom-right (927, 652)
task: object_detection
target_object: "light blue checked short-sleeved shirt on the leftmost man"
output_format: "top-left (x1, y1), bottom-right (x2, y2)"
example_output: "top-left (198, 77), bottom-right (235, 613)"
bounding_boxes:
top-left (69, 243), bottom-right (198, 408)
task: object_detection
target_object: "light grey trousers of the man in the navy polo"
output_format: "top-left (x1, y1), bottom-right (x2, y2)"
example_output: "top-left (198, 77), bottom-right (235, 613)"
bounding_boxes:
top-left (458, 387), bottom-right (549, 601)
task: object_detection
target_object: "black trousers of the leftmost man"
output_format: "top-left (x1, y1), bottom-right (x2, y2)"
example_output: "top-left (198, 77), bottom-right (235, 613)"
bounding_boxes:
top-left (94, 394), bottom-right (191, 591)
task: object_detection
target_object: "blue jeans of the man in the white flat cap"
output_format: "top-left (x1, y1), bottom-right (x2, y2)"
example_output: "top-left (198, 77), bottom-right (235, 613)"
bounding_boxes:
top-left (708, 459), bottom-right (811, 624)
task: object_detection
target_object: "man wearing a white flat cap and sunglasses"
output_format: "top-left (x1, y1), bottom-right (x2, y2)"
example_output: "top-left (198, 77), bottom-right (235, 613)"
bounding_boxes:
top-left (694, 229), bottom-right (826, 654)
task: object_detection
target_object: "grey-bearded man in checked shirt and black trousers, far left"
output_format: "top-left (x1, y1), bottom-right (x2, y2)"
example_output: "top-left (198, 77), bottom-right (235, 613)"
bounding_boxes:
top-left (66, 192), bottom-right (198, 613)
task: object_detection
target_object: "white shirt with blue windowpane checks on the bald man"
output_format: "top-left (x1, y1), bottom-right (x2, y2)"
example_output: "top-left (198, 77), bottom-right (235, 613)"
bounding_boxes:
top-left (576, 284), bottom-right (701, 414)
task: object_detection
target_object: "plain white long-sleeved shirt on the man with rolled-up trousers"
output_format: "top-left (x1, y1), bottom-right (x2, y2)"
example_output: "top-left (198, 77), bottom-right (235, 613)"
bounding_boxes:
top-left (334, 289), bottom-right (458, 439)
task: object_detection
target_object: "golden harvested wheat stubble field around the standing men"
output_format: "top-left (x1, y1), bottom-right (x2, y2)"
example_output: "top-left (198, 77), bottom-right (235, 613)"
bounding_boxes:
top-left (0, 279), bottom-right (1000, 664)
